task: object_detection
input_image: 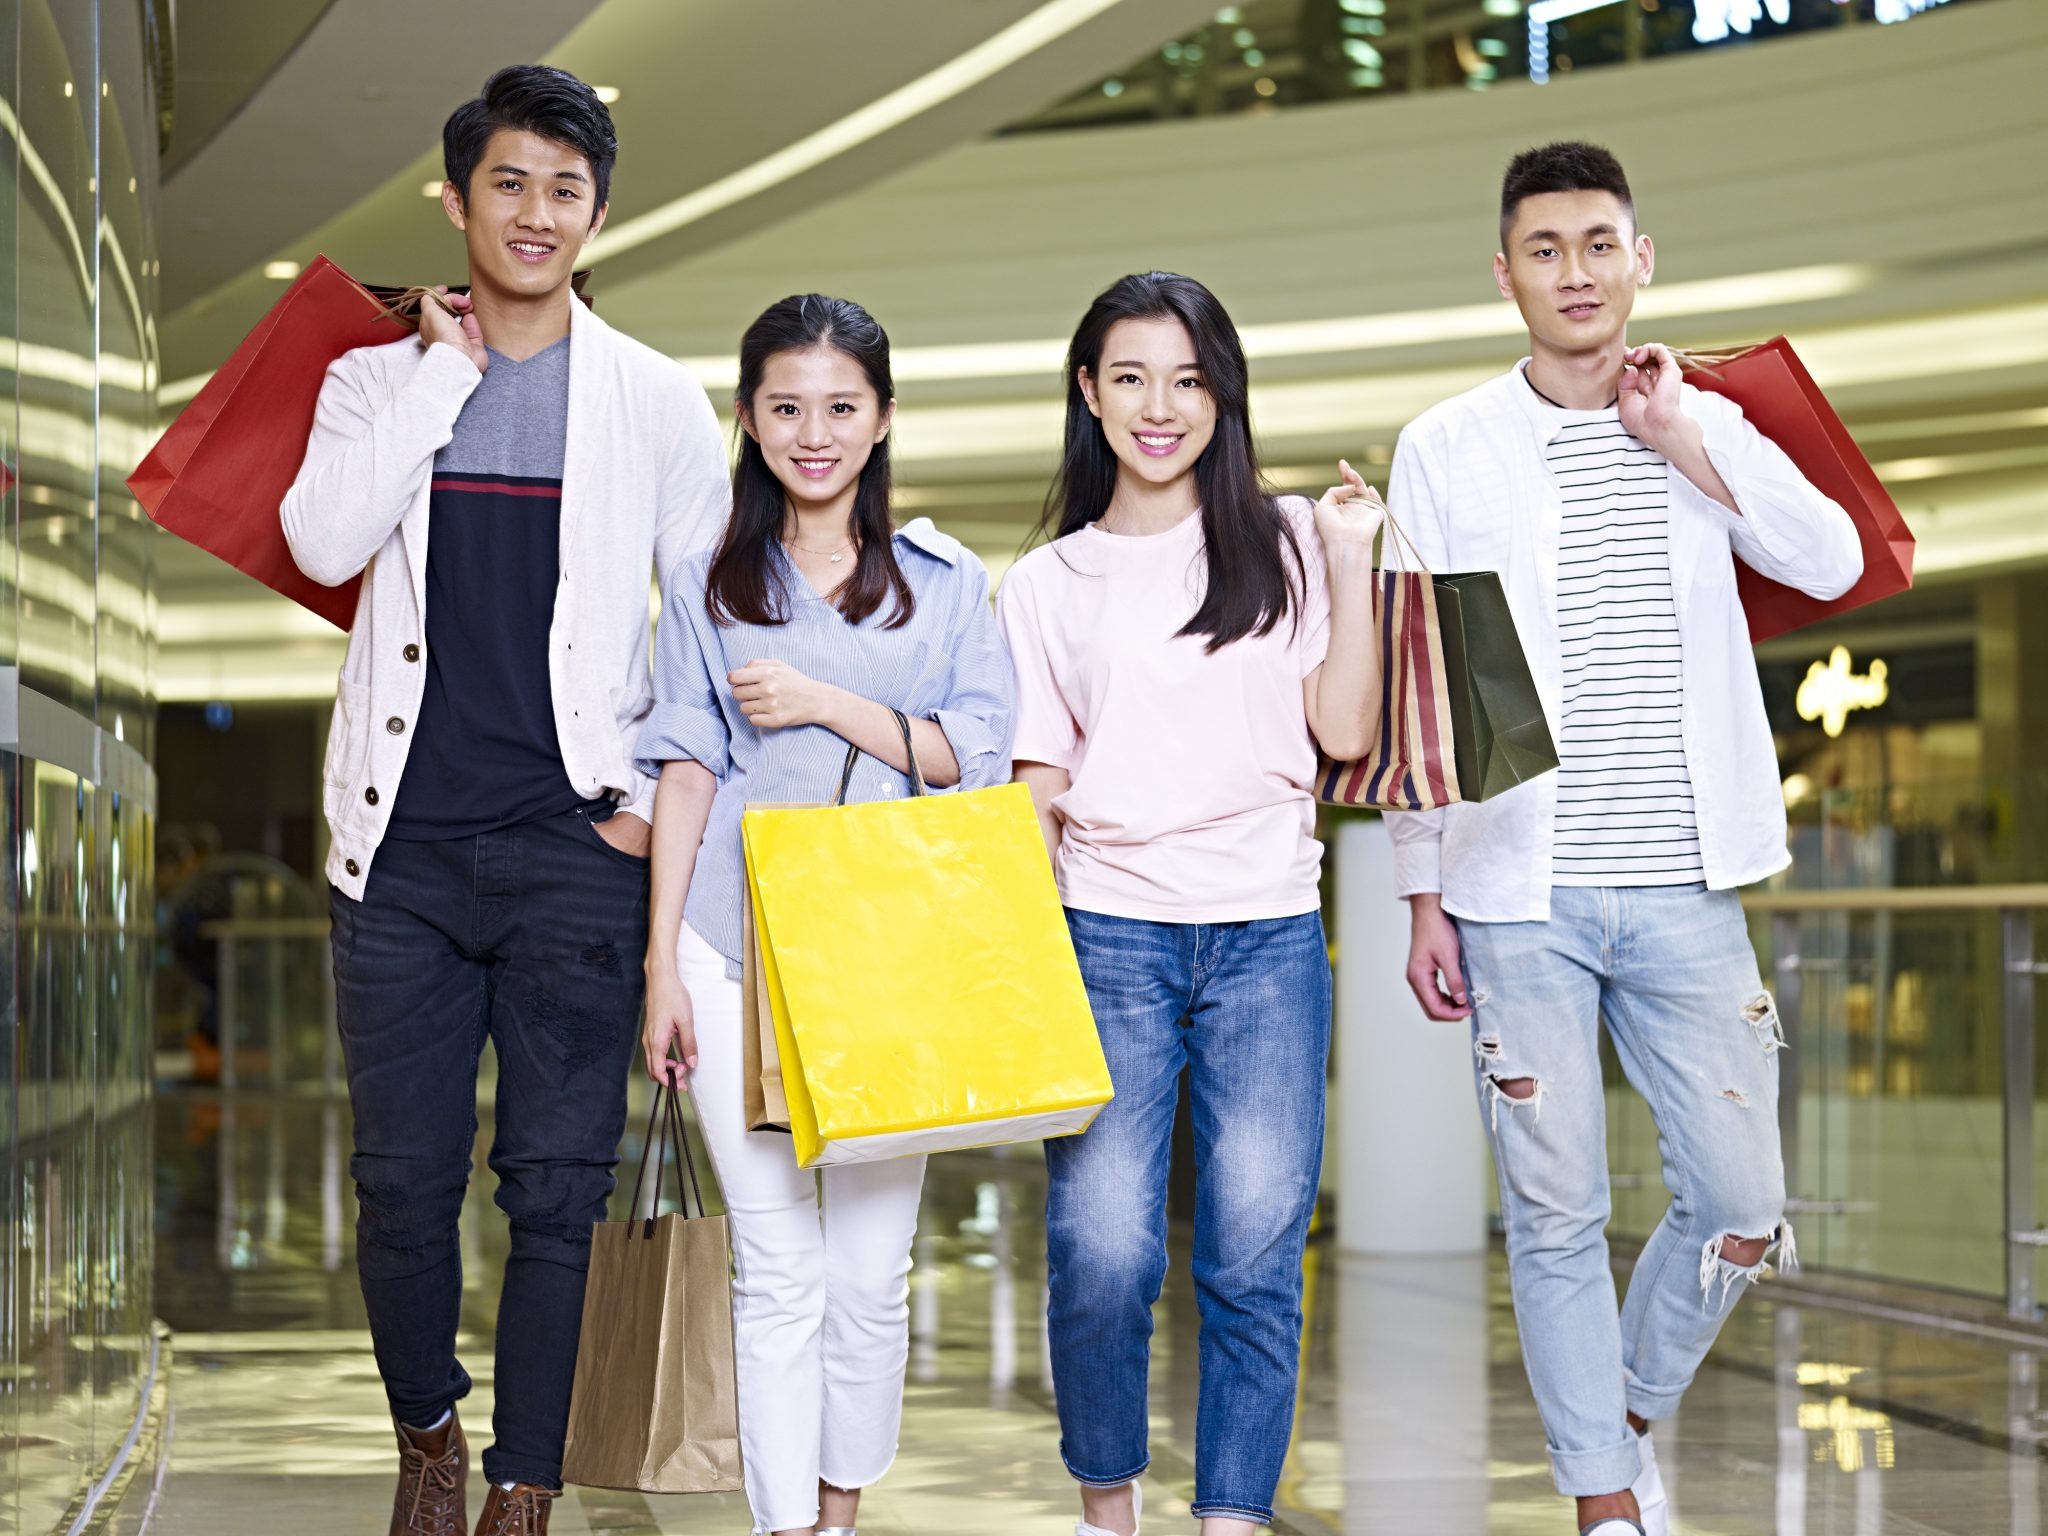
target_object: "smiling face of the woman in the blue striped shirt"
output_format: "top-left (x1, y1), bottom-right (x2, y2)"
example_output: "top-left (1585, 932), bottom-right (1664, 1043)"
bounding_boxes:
top-left (739, 346), bottom-right (895, 512)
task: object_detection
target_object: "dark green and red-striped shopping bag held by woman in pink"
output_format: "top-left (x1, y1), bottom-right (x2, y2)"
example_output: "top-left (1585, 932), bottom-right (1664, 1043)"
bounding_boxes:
top-left (1317, 518), bottom-right (1556, 811)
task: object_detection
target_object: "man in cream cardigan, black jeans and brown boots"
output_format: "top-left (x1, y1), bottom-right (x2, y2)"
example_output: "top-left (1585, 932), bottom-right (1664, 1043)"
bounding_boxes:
top-left (283, 66), bottom-right (729, 1536)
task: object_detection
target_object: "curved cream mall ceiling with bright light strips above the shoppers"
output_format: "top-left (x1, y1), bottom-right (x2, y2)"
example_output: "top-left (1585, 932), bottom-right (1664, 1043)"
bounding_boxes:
top-left (158, 0), bottom-right (2048, 702)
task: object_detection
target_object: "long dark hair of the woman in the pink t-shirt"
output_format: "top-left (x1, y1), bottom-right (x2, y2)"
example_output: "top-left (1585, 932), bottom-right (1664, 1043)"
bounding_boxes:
top-left (1038, 272), bottom-right (1305, 651)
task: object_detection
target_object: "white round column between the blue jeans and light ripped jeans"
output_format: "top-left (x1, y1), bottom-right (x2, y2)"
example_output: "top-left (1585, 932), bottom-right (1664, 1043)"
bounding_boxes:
top-left (1331, 819), bottom-right (1491, 1255)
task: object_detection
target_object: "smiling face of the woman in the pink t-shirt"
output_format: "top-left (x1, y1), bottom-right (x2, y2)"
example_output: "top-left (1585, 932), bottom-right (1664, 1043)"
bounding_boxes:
top-left (1079, 319), bottom-right (1217, 485)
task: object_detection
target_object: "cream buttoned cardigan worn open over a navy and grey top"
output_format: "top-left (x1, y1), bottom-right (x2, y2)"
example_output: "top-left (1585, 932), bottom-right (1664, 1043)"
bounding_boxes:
top-left (281, 303), bottom-right (731, 899)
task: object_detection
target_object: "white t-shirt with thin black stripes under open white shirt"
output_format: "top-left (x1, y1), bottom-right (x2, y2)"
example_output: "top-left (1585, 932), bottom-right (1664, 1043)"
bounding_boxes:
top-left (1544, 403), bottom-right (1706, 885)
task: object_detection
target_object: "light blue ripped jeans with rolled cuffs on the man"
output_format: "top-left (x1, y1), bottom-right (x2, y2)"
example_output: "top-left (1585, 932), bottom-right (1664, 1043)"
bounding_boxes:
top-left (1458, 885), bottom-right (1794, 1495)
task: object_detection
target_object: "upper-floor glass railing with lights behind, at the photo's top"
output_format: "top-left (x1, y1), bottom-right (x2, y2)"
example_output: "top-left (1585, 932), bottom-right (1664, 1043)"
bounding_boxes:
top-left (1010, 0), bottom-right (1998, 133)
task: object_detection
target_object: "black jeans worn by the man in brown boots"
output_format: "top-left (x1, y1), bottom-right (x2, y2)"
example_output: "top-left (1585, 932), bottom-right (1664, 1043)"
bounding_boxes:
top-left (332, 811), bottom-right (647, 1487)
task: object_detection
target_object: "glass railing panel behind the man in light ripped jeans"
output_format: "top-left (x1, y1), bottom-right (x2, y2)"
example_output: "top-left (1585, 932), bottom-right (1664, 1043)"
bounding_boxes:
top-left (1608, 883), bottom-right (2048, 1321)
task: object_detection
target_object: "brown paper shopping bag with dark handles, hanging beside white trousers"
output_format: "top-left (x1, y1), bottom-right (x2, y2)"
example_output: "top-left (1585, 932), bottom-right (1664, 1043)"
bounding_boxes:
top-left (561, 1087), bottom-right (739, 1493)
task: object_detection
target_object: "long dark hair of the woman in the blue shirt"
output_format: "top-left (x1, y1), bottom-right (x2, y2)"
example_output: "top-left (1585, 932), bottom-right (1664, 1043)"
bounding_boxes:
top-left (705, 293), bottom-right (918, 629)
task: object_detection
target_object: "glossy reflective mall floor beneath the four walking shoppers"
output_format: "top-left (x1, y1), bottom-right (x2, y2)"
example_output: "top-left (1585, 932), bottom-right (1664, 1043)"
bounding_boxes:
top-left (156, 1094), bottom-right (2048, 1536)
